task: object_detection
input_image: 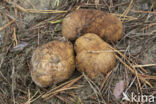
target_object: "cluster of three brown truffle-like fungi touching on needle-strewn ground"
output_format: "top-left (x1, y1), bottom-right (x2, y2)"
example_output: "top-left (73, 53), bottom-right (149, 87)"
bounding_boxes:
top-left (31, 9), bottom-right (123, 87)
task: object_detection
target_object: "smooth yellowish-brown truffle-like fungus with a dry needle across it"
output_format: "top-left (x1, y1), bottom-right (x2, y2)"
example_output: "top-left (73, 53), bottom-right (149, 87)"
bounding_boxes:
top-left (75, 33), bottom-right (116, 79)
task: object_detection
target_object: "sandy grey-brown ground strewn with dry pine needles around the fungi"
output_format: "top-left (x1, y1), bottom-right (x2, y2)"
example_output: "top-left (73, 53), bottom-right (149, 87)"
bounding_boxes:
top-left (0, 0), bottom-right (156, 104)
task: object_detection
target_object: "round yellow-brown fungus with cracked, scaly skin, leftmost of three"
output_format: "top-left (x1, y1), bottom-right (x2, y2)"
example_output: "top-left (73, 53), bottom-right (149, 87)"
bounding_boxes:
top-left (31, 40), bottom-right (75, 87)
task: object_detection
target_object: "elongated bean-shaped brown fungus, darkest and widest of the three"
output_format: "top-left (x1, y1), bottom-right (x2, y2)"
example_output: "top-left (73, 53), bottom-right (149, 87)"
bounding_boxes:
top-left (62, 9), bottom-right (123, 42)
